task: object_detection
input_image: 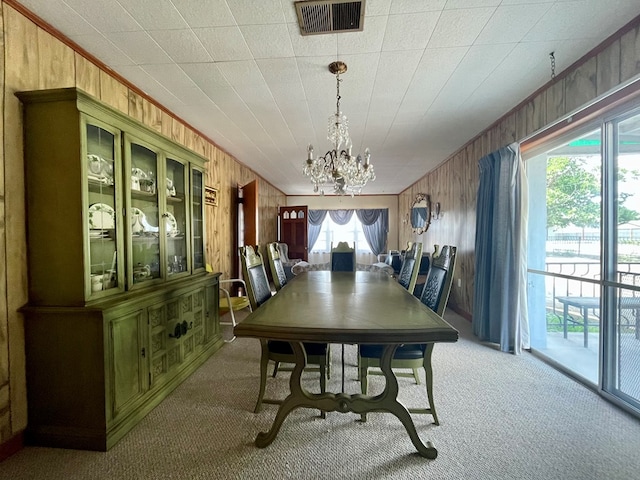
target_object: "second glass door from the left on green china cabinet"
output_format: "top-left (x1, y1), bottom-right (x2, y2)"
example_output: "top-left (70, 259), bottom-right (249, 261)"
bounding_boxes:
top-left (125, 141), bottom-right (161, 286)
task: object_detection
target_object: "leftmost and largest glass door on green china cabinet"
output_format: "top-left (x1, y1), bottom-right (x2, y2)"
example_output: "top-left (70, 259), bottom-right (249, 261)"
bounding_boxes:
top-left (83, 119), bottom-right (123, 297)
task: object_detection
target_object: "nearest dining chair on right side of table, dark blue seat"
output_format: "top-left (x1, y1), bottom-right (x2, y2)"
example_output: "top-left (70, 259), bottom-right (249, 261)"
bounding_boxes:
top-left (358, 245), bottom-right (457, 425)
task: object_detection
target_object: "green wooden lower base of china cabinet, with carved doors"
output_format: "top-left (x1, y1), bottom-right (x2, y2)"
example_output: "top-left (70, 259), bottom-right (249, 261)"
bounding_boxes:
top-left (23, 274), bottom-right (224, 451)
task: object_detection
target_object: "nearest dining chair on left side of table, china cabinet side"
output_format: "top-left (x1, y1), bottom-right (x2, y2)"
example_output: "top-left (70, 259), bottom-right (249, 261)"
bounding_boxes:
top-left (239, 245), bottom-right (329, 418)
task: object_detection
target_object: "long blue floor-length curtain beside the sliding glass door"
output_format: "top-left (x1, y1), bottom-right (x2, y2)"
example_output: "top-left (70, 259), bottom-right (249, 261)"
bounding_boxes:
top-left (472, 143), bottom-right (529, 354)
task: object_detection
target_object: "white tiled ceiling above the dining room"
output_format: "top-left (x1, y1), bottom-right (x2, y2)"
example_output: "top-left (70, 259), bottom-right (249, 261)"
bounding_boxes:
top-left (12, 0), bottom-right (640, 195)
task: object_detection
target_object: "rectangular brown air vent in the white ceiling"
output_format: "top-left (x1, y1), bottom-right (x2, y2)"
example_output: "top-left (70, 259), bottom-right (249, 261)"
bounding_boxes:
top-left (295, 0), bottom-right (365, 35)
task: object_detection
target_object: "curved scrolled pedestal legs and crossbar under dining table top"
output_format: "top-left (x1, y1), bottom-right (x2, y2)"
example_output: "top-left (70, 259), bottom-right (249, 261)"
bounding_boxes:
top-left (255, 342), bottom-right (438, 459)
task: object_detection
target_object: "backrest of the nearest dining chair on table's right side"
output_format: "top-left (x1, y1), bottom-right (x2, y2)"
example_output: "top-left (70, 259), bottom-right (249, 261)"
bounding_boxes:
top-left (420, 245), bottom-right (457, 316)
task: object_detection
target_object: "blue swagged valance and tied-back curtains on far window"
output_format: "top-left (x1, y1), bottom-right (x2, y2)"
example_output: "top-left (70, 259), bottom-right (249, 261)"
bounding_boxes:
top-left (308, 208), bottom-right (389, 255)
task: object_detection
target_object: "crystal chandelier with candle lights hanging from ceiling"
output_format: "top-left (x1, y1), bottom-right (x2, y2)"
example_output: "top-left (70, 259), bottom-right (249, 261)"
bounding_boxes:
top-left (303, 61), bottom-right (376, 196)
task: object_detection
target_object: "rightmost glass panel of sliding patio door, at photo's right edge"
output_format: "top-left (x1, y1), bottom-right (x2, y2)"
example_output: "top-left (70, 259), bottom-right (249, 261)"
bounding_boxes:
top-left (603, 111), bottom-right (640, 407)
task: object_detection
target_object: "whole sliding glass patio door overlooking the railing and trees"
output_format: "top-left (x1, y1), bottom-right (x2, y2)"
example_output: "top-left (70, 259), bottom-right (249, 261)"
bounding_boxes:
top-left (524, 104), bottom-right (640, 412)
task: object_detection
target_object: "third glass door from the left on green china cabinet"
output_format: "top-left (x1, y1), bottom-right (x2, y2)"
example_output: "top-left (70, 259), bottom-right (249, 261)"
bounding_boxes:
top-left (162, 158), bottom-right (189, 277)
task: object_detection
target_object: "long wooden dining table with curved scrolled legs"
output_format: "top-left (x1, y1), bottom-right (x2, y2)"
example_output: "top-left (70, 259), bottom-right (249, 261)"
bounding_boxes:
top-left (234, 271), bottom-right (458, 459)
